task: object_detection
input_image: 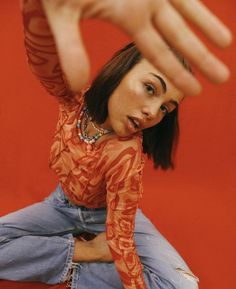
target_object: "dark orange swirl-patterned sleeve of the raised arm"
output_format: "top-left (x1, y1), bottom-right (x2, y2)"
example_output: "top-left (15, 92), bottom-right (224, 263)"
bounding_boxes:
top-left (22, 0), bottom-right (78, 104)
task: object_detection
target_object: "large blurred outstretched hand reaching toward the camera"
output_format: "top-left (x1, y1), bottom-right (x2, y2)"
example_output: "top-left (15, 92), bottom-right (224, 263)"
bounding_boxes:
top-left (42, 0), bottom-right (232, 95)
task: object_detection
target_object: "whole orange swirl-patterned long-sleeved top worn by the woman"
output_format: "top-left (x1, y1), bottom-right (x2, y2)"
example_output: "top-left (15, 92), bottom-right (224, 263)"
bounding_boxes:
top-left (23, 0), bottom-right (146, 289)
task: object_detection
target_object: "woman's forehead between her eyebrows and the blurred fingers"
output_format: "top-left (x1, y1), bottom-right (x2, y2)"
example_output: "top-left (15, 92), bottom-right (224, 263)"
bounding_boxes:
top-left (130, 58), bottom-right (184, 101)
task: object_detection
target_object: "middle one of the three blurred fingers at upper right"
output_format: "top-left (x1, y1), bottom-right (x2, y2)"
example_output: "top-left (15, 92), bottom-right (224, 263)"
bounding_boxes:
top-left (154, 5), bottom-right (229, 83)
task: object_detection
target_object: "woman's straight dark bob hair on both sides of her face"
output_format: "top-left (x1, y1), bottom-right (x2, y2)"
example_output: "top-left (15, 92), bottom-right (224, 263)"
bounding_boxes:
top-left (85, 43), bottom-right (191, 170)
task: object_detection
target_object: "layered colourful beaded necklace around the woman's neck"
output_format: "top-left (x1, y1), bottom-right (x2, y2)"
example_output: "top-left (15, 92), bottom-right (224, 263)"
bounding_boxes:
top-left (77, 107), bottom-right (112, 144)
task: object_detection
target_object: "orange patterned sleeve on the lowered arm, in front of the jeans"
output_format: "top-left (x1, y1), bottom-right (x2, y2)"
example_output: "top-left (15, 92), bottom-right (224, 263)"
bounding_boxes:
top-left (106, 138), bottom-right (146, 289)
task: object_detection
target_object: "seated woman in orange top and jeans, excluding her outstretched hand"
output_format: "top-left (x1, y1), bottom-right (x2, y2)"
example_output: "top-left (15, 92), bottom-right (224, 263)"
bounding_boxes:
top-left (0, 0), bottom-right (197, 289)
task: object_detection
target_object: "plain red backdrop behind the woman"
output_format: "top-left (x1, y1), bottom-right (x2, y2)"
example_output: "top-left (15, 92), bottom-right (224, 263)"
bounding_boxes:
top-left (0, 0), bottom-right (236, 289)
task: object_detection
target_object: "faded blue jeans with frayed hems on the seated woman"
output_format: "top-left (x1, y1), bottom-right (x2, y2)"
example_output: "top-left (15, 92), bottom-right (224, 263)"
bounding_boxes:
top-left (0, 185), bottom-right (198, 289)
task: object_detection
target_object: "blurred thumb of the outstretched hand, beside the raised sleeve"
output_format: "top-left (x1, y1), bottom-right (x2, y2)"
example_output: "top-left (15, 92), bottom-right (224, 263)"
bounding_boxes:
top-left (43, 1), bottom-right (90, 92)
